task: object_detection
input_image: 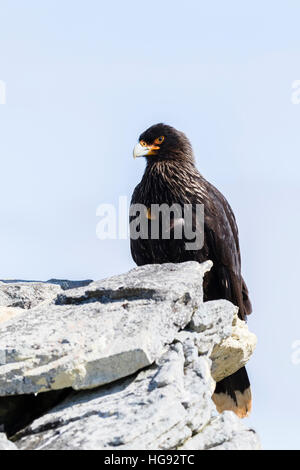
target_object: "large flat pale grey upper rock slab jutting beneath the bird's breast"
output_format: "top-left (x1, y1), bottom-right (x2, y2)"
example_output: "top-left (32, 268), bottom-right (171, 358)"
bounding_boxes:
top-left (0, 262), bottom-right (211, 396)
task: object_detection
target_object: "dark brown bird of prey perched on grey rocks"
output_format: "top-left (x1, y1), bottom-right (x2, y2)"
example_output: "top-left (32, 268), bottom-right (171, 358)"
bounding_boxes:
top-left (130, 124), bottom-right (252, 418)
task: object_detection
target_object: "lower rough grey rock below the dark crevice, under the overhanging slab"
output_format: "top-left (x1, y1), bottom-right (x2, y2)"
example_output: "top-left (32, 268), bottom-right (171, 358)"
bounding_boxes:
top-left (16, 337), bottom-right (259, 450)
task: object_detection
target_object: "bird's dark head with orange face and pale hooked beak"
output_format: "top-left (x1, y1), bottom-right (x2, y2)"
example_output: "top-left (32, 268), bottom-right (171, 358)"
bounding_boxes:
top-left (133, 124), bottom-right (194, 162)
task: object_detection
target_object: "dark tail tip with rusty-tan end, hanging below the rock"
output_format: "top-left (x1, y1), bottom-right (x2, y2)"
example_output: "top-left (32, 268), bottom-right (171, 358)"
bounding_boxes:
top-left (212, 367), bottom-right (251, 418)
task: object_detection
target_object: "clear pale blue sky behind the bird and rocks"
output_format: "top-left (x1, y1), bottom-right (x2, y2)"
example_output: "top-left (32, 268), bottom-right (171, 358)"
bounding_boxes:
top-left (0, 0), bottom-right (300, 449)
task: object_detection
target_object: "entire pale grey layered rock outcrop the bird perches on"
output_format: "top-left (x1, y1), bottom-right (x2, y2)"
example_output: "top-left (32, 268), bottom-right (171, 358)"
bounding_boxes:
top-left (0, 262), bottom-right (260, 450)
